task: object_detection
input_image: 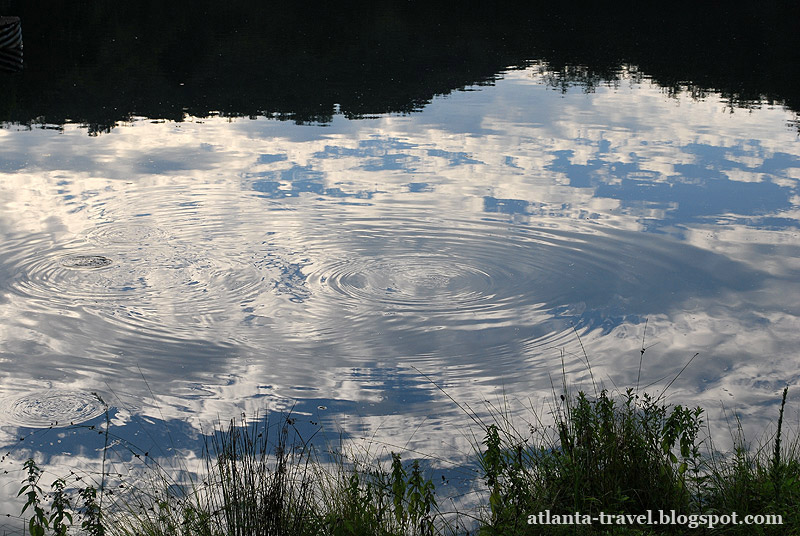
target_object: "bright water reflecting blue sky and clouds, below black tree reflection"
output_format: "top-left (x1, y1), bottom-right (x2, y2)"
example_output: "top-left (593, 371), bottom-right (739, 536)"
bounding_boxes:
top-left (0, 64), bottom-right (800, 524)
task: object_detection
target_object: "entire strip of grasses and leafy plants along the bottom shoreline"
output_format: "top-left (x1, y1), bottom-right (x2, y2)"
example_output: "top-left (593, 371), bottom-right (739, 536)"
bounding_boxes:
top-left (3, 350), bottom-right (800, 536)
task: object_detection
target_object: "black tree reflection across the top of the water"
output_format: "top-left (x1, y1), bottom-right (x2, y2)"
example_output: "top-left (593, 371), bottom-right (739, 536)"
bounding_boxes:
top-left (0, 0), bottom-right (800, 131)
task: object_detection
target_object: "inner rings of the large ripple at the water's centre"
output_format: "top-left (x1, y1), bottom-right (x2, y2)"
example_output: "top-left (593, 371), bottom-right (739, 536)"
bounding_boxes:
top-left (306, 221), bottom-right (611, 318)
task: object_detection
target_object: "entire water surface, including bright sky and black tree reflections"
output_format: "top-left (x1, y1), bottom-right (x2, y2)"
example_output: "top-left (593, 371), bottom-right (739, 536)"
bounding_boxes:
top-left (0, 0), bottom-right (800, 527)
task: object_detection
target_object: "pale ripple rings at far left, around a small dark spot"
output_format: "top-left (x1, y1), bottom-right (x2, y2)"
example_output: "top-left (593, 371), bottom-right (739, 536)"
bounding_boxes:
top-left (9, 241), bottom-right (273, 336)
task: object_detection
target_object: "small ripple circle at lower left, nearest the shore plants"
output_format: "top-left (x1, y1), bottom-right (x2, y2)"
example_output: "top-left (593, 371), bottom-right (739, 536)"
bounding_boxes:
top-left (0, 389), bottom-right (105, 428)
